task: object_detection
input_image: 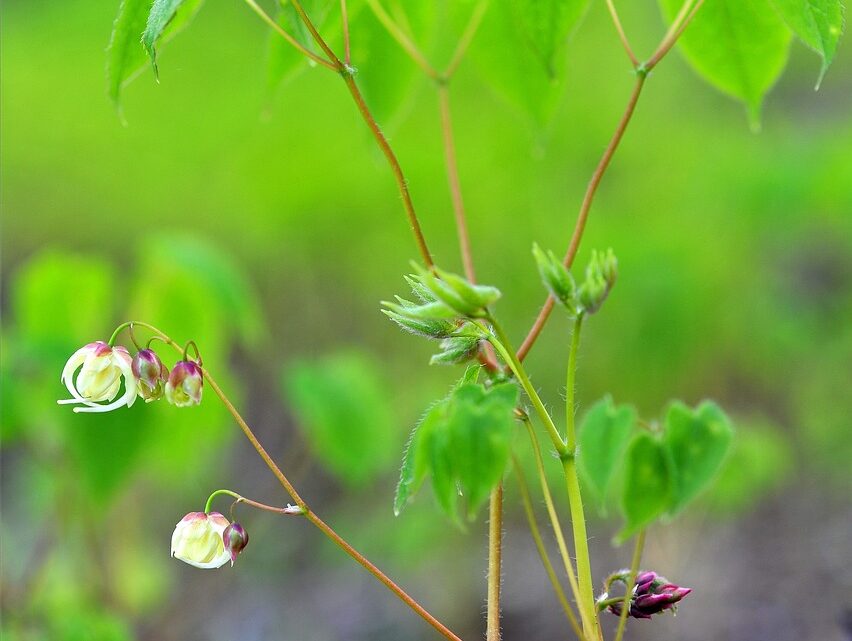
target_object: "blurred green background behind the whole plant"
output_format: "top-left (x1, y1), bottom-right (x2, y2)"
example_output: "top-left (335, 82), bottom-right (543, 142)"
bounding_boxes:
top-left (0, 0), bottom-right (852, 641)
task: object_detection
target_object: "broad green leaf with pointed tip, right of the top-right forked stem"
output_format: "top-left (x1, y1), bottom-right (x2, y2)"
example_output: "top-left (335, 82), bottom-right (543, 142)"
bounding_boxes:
top-left (660, 0), bottom-right (790, 126)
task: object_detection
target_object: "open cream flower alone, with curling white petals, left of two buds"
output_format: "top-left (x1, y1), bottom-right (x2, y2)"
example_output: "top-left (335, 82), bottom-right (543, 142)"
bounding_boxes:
top-left (58, 341), bottom-right (136, 412)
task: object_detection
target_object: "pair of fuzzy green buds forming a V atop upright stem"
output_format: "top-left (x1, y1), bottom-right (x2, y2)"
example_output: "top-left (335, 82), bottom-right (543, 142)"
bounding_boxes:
top-left (533, 245), bottom-right (618, 317)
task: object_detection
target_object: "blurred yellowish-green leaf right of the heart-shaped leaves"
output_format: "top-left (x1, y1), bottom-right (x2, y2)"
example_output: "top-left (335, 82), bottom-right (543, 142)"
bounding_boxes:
top-left (707, 426), bottom-right (793, 514)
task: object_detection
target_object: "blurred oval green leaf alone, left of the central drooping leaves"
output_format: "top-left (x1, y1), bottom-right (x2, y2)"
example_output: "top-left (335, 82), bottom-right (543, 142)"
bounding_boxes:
top-left (284, 353), bottom-right (396, 486)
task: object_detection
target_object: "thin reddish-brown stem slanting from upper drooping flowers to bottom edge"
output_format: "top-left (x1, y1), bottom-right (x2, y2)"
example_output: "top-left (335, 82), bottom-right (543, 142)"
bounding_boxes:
top-left (125, 321), bottom-right (461, 641)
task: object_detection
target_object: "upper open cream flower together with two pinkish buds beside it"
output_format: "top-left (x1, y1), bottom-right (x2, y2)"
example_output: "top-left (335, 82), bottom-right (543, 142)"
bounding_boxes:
top-left (59, 341), bottom-right (204, 412)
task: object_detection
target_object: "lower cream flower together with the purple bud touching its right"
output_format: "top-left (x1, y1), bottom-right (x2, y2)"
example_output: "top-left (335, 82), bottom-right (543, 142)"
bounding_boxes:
top-left (172, 512), bottom-right (248, 570)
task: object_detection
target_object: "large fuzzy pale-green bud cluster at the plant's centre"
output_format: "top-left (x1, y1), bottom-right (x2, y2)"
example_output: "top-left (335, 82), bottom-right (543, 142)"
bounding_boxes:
top-left (382, 268), bottom-right (500, 365)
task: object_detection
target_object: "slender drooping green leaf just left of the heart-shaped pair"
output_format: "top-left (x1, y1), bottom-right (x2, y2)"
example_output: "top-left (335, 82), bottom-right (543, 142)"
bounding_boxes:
top-left (577, 396), bottom-right (636, 513)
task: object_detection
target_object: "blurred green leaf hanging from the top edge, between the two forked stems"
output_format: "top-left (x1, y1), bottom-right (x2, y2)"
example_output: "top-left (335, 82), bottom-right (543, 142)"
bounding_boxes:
top-left (470, 0), bottom-right (588, 125)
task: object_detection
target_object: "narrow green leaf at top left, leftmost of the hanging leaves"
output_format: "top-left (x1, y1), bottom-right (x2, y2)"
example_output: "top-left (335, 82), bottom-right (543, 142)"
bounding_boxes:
top-left (107, 0), bottom-right (151, 105)
